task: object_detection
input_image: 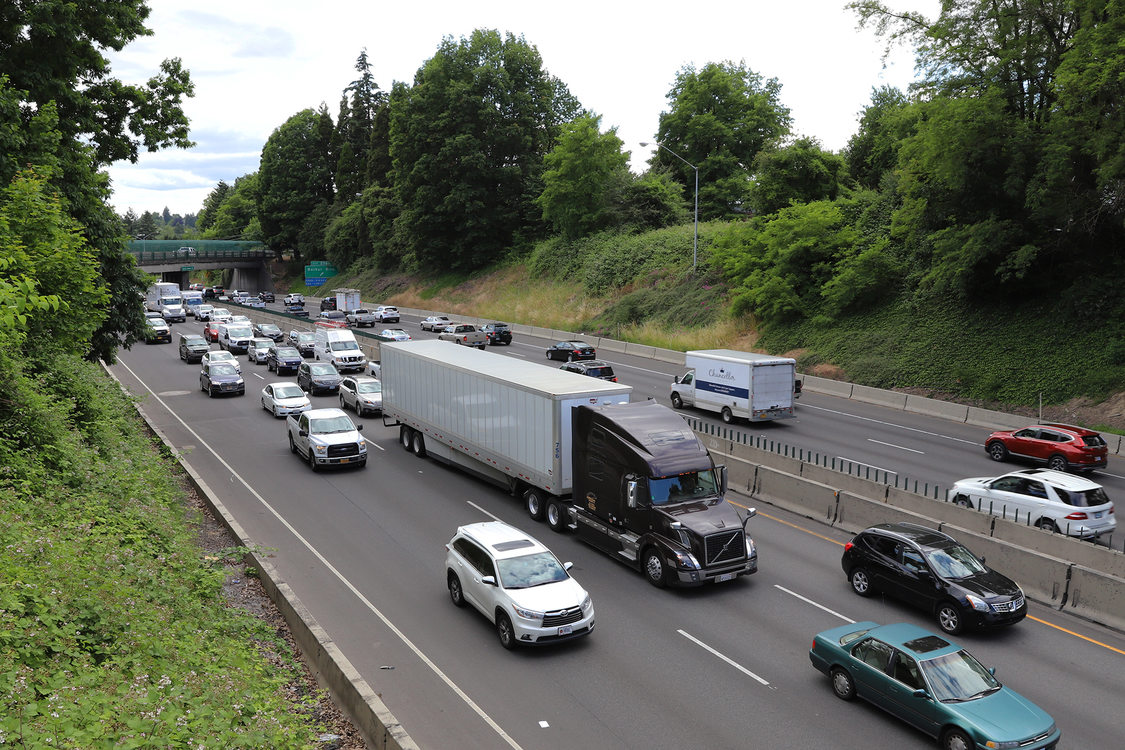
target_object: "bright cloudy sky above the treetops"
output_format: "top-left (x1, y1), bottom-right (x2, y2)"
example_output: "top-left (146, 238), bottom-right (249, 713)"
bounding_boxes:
top-left (109, 0), bottom-right (939, 214)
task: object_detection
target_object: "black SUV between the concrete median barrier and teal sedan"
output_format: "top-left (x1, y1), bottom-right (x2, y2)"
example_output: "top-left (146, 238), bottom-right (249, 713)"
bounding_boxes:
top-left (840, 523), bottom-right (1027, 635)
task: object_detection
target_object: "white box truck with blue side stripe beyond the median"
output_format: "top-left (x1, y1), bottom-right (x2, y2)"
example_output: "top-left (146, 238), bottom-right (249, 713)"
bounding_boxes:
top-left (672, 349), bottom-right (801, 424)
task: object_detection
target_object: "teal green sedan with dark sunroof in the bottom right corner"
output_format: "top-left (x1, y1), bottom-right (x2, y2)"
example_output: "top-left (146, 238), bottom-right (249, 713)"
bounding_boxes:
top-left (809, 622), bottom-right (1062, 750)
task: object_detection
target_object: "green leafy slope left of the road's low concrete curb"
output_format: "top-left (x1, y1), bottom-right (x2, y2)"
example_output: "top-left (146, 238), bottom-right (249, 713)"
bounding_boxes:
top-left (0, 352), bottom-right (322, 748)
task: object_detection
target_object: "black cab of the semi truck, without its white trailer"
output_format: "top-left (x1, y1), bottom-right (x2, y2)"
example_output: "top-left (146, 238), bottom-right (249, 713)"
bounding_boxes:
top-left (570, 400), bottom-right (757, 586)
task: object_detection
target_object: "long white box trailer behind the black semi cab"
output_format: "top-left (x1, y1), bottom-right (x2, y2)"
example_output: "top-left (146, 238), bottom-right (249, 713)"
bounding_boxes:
top-left (379, 340), bottom-right (632, 496)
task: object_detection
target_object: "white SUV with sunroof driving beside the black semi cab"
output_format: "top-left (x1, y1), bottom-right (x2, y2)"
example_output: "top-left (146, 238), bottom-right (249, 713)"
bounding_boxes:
top-left (446, 521), bottom-right (594, 649)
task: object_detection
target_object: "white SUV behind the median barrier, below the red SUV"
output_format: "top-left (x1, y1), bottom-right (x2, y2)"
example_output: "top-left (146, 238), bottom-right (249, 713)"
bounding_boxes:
top-left (947, 469), bottom-right (1117, 539)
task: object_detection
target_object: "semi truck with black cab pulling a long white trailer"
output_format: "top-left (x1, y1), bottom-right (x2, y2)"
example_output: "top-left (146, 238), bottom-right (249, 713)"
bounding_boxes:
top-left (380, 340), bottom-right (757, 586)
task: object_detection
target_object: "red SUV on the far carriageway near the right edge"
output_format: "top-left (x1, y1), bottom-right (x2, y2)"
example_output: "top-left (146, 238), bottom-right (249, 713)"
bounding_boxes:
top-left (984, 423), bottom-right (1108, 471)
